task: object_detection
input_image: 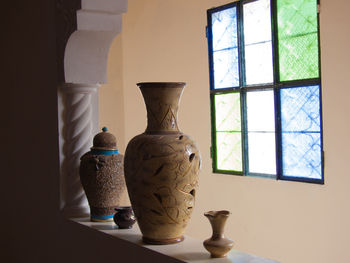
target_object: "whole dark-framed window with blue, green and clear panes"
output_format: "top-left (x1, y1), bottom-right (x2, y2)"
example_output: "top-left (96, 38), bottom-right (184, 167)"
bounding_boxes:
top-left (207, 0), bottom-right (324, 184)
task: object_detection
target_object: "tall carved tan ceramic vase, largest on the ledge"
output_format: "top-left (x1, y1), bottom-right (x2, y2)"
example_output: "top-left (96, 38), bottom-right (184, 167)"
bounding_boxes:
top-left (124, 82), bottom-right (201, 244)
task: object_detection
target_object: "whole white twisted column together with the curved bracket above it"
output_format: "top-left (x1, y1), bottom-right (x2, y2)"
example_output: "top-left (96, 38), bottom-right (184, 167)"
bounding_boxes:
top-left (56, 0), bottom-right (127, 219)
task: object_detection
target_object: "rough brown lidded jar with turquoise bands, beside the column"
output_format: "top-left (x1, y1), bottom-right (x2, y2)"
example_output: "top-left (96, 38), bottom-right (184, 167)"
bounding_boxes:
top-left (79, 127), bottom-right (126, 221)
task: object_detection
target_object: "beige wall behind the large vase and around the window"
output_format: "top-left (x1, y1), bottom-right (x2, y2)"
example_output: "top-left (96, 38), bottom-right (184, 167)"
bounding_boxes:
top-left (100, 0), bottom-right (350, 263)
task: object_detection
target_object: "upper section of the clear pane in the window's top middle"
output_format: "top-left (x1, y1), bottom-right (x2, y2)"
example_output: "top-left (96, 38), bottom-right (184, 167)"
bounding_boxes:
top-left (243, 0), bottom-right (271, 45)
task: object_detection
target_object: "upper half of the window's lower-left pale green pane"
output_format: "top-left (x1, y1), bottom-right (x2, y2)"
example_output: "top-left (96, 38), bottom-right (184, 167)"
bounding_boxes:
top-left (215, 93), bottom-right (241, 131)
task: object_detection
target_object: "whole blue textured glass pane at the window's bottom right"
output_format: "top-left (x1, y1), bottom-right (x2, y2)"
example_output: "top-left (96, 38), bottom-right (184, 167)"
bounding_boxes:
top-left (280, 86), bottom-right (322, 179)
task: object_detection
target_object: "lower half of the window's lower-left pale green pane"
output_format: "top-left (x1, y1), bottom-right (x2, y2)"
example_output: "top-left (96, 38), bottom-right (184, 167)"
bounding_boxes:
top-left (216, 132), bottom-right (242, 172)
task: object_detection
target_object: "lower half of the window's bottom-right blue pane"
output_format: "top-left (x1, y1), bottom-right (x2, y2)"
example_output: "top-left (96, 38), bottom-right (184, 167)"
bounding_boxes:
top-left (282, 132), bottom-right (322, 179)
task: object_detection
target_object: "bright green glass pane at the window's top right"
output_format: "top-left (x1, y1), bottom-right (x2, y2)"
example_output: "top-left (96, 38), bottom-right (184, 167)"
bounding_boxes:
top-left (277, 0), bottom-right (319, 81)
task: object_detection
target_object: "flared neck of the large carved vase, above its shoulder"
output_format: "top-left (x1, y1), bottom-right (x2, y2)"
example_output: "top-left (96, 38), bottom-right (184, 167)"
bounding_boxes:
top-left (138, 83), bottom-right (184, 133)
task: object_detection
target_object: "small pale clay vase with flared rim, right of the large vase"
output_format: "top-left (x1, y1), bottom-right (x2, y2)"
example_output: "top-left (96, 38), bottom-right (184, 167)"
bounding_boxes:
top-left (203, 210), bottom-right (233, 258)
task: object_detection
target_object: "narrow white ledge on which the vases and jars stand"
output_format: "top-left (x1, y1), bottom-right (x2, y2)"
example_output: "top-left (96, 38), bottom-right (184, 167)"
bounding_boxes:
top-left (71, 218), bottom-right (278, 263)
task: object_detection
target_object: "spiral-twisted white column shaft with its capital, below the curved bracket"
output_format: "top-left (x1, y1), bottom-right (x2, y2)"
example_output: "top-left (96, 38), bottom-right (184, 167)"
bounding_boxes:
top-left (59, 83), bottom-right (99, 217)
